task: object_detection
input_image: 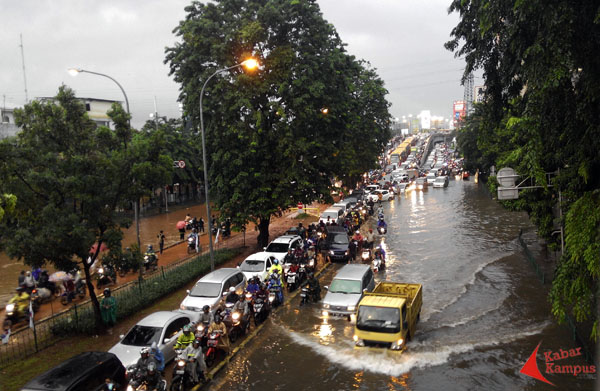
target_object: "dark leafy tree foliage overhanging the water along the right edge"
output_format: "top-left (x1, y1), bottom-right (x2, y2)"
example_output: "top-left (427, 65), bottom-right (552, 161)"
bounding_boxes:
top-left (446, 0), bottom-right (600, 338)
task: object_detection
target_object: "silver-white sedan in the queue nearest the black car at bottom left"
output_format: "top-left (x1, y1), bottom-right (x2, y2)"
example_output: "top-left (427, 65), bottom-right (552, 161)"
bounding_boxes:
top-left (108, 311), bottom-right (190, 368)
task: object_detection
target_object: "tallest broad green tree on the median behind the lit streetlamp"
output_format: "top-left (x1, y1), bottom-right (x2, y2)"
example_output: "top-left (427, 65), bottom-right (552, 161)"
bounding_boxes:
top-left (166, 0), bottom-right (390, 246)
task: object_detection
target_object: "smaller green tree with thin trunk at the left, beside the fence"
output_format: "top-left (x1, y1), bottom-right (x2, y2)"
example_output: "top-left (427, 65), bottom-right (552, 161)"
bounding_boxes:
top-left (0, 86), bottom-right (170, 327)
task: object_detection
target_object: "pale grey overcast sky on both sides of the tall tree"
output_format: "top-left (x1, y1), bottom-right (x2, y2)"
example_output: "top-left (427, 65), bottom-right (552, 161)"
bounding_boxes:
top-left (0, 0), bottom-right (464, 127)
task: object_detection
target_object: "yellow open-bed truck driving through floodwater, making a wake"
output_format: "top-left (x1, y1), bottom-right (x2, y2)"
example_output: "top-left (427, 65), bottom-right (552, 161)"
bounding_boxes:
top-left (354, 282), bottom-right (423, 350)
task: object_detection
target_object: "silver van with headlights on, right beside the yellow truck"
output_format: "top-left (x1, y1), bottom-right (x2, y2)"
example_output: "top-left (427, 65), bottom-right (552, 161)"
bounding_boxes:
top-left (322, 264), bottom-right (375, 317)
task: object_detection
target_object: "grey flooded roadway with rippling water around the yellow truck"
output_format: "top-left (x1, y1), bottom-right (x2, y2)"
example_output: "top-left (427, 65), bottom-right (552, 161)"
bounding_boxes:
top-left (210, 181), bottom-right (594, 391)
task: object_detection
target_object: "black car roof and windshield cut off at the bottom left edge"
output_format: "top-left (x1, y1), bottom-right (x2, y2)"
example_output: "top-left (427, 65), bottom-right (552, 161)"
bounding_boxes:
top-left (21, 352), bottom-right (127, 391)
